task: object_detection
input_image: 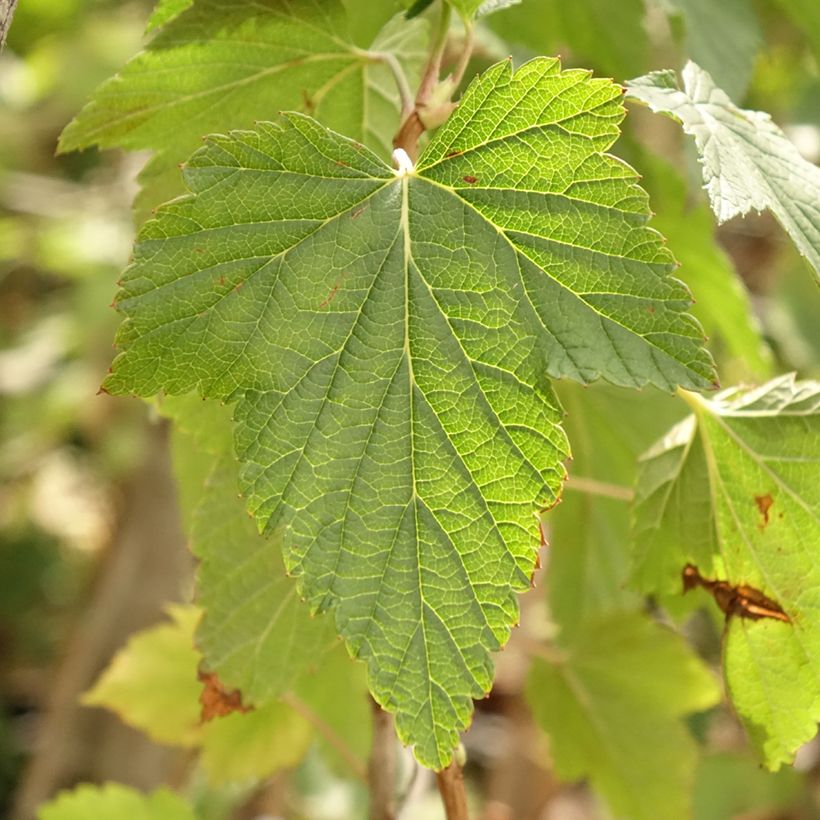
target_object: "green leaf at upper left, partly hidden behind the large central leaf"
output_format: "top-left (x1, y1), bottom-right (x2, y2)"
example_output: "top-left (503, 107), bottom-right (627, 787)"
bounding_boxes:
top-left (59, 0), bottom-right (426, 207)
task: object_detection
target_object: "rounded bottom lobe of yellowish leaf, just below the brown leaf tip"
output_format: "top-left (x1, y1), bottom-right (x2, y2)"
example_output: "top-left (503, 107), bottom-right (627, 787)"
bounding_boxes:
top-left (200, 702), bottom-right (313, 785)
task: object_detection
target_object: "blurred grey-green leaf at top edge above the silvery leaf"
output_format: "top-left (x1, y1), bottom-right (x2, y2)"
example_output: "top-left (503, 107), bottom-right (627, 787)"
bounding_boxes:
top-left (663, 0), bottom-right (763, 99)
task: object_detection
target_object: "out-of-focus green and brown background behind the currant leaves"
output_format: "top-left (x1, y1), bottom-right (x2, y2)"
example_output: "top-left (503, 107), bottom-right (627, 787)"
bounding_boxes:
top-left (0, 0), bottom-right (820, 820)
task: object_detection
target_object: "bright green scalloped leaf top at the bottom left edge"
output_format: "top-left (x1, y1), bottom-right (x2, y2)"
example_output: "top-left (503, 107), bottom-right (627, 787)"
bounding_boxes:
top-left (37, 783), bottom-right (196, 820)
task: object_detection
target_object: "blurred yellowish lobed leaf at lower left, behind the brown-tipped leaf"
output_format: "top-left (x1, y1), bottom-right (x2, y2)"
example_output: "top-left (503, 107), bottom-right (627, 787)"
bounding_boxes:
top-left (84, 606), bottom-right (368, 784)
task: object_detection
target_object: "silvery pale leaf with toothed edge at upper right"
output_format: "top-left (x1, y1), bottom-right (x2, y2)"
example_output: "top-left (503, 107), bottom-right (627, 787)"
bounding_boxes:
top-left (627, 62), bottom-right (820, 279)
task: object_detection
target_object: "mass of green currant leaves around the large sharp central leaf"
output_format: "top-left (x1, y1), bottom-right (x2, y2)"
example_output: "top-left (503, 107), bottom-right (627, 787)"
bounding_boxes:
top-left (52, 0), bottom-right (820, 818)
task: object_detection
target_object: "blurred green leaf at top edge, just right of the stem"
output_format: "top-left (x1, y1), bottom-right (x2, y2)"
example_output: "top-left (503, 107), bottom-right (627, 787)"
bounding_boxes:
top-left (490, 0), bottom-right (649, 80)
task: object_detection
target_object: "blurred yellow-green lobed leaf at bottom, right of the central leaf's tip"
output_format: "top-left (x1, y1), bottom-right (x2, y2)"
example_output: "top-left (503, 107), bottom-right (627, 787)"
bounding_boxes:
top-left (527, 614), bottom-right (719, 820)
